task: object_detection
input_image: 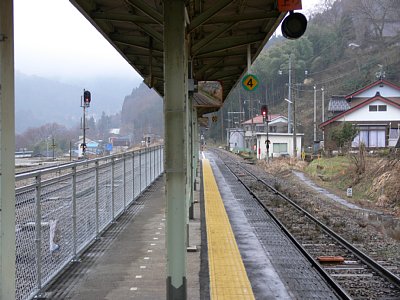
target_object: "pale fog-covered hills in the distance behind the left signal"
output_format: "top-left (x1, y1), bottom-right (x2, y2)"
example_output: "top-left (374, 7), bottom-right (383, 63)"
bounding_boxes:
top-left (15, 71), bottom-right (140, 133)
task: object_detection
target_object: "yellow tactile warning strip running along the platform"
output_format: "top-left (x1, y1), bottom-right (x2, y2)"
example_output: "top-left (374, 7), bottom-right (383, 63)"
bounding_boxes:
top-left (203, 159), bottom-right (254, 300)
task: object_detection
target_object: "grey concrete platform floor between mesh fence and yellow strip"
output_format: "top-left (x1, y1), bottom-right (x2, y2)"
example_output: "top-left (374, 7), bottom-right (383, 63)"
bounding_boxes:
top-left (45, 178), bottom-right (200, 300)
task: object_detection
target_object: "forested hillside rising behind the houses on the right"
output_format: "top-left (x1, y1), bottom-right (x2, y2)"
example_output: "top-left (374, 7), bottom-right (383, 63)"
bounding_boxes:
top-left (210, 0), bottom-right (400, 145)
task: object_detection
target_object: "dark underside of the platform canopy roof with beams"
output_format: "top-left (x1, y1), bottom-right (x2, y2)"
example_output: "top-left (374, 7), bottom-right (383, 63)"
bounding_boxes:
top-left (71, 0), bottom-right (285, 105)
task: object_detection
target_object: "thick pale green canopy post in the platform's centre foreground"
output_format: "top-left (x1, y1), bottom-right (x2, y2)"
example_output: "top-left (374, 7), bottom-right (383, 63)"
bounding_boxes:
top-left (164, 0), bottom-right (188, 300)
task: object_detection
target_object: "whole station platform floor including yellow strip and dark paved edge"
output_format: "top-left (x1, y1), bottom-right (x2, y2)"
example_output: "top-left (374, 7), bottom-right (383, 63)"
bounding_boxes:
top-left (45, 152), bottom-right (337, 300)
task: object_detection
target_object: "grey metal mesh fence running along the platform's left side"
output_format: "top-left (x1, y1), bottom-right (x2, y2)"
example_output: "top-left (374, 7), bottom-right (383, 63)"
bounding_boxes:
top-left (15, 146), bottom-right (164, 300)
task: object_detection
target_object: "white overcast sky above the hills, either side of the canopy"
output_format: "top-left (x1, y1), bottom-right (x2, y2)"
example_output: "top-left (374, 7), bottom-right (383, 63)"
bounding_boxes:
top-left (14, 0), bottom-right (321, 83)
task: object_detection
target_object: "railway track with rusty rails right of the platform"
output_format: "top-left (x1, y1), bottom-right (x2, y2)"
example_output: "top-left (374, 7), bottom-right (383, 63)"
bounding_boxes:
top-left (215, 150), bottom-right (400, 300)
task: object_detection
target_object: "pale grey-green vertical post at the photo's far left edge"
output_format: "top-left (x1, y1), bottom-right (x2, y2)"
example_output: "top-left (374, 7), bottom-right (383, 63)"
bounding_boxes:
top-left (0, 0), bottom-right (16, 300)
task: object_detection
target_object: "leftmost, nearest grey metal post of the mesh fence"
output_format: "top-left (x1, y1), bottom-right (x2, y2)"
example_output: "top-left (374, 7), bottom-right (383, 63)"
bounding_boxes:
top-left (35, 174), bottom-right (42, 297)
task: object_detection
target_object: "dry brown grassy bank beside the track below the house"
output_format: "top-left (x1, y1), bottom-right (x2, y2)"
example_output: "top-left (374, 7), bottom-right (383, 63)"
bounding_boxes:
top-left (257, 157), bottom-right (400, 217)
